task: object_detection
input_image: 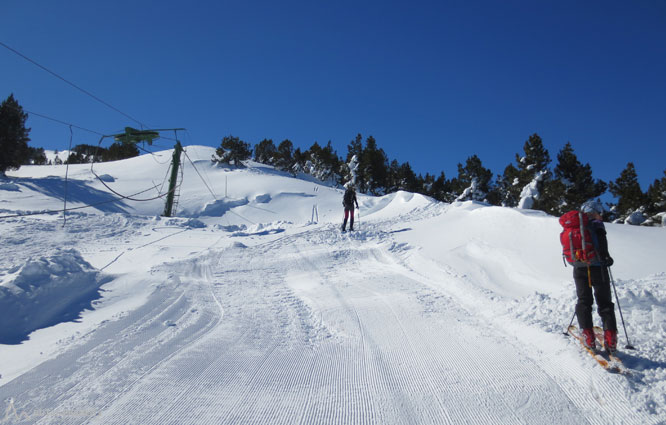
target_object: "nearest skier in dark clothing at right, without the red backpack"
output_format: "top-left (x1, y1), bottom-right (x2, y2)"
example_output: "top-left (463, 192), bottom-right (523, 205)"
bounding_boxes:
top-left (573, 201), bottom-right (617, 352)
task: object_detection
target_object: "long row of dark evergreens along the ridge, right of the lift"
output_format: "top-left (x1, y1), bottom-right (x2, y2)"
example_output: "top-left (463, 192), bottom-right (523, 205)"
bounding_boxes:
top-left (213, 134), bottom-right (666, 225)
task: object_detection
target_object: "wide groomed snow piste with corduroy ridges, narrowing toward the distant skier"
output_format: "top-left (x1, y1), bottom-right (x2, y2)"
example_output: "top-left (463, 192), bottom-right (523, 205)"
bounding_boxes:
top-left (0, 220), bottom-right (654, 425)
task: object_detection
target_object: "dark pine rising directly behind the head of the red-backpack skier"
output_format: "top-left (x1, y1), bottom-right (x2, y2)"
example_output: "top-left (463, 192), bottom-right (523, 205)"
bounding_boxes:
top-left (553, 142), bottom-right (607, 215)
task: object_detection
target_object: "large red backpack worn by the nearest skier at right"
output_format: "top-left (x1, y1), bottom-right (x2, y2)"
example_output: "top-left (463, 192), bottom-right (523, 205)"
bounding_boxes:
top-left (560, 211), bottom-right (597, 267)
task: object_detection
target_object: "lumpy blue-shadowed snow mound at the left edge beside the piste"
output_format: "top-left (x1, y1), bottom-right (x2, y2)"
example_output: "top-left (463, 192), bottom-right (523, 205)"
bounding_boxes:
top-left (0, 249), bottom-right (103, 344)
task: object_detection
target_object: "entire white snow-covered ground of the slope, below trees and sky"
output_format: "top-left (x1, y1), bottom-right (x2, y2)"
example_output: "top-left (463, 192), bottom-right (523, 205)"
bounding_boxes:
top-left (0, 146), bottom-right (666, 425)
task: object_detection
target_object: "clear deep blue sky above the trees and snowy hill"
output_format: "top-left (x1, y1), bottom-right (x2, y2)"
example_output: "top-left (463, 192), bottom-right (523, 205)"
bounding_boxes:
top-left (0, 0), bottom-right (666, 190)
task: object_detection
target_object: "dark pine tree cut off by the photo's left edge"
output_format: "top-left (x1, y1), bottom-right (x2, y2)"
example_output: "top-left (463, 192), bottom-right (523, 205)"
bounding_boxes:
top-left (0, 94), bottom-right (30, 175)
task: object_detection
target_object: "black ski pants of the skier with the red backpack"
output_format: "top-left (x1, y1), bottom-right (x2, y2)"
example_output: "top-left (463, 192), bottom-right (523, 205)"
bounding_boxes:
top-left (574, 266), bottom-right (617, 331)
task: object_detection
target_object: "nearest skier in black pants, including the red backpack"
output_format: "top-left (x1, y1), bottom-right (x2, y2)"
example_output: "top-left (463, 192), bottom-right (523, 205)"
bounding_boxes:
top-left (560, 201), bottom-right (617, 353)
